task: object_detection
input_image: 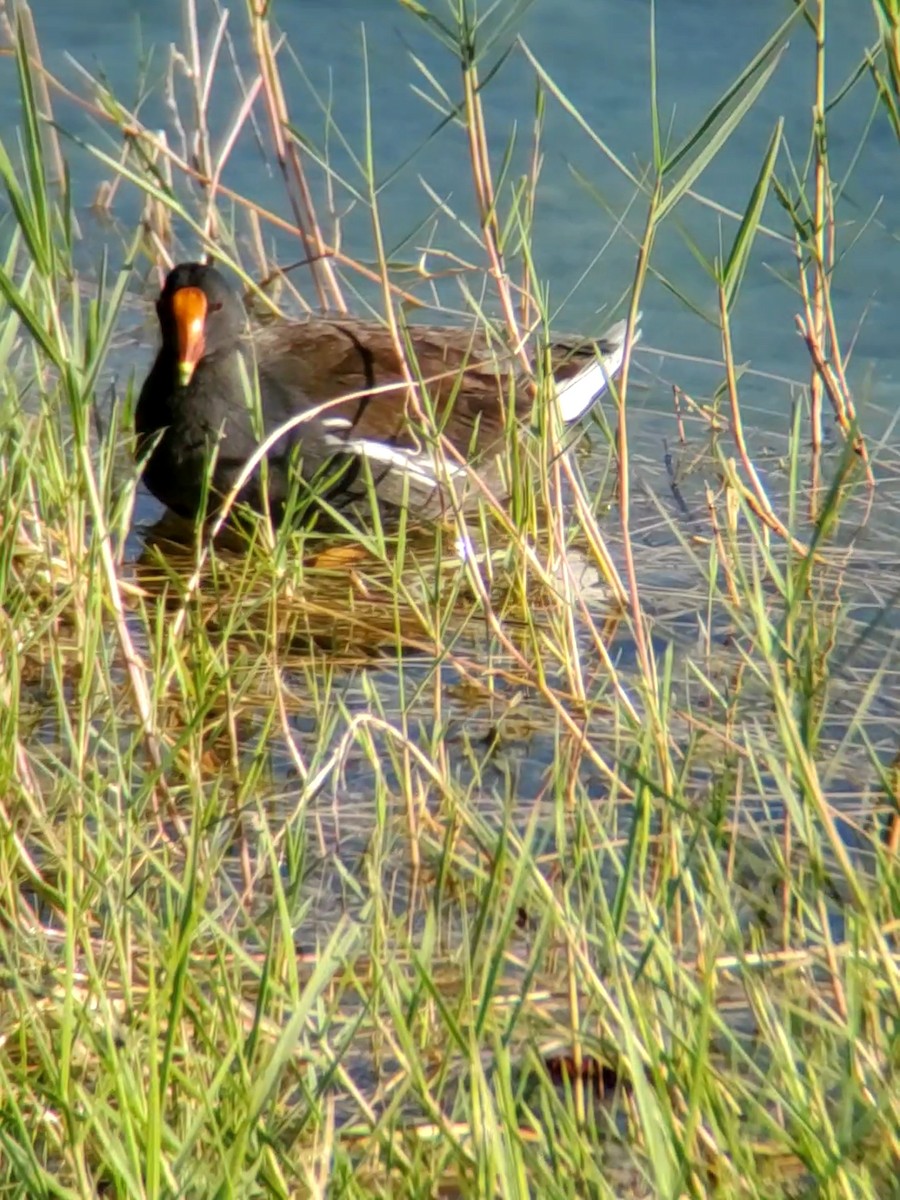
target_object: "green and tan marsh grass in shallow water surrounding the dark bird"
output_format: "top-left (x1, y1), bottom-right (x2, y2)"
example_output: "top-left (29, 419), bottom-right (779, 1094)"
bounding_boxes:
top-left (0, 0), bottom-right (900, 1200)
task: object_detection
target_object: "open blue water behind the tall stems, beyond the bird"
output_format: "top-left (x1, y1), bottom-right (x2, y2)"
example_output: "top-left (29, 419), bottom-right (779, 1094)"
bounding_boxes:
top-left (12, 0), bottom-right (900, 412)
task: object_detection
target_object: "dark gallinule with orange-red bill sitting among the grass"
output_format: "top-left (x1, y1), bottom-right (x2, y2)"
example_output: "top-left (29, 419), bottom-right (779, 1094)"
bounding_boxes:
top-left (134, 263), bottom-right (643, 518)
